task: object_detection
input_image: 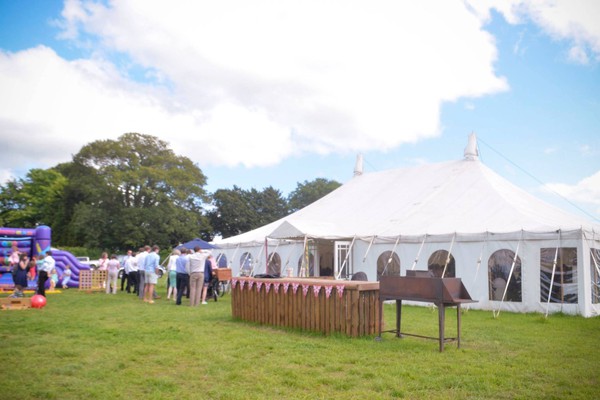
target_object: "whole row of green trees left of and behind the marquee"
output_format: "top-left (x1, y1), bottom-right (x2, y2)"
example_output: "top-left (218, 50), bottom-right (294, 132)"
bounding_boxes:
top-left (0, 133), bottom-right (340, 250)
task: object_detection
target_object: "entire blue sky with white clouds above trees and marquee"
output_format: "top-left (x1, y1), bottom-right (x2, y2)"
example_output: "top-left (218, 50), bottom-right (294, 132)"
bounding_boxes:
top-left (0, 0), bottom-right (600, 220)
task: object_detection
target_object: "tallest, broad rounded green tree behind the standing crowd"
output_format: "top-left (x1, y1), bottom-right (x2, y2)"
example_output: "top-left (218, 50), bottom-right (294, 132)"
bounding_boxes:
top-left (58, 133), bottom-right (211, 249)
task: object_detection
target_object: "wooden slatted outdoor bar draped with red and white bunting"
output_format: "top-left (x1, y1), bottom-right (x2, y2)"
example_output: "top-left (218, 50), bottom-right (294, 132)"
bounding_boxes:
top-left (231, 277), bottom-right (380, 337)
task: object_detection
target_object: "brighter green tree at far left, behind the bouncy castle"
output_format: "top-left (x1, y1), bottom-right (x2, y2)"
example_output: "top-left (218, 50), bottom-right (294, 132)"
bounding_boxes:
top-left (0, 169), bottom-right (67, 228)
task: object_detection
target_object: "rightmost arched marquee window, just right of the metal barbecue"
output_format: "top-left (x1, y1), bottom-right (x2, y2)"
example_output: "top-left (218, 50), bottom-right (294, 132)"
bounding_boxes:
top-left (488, 249), bottom-right (522, 301)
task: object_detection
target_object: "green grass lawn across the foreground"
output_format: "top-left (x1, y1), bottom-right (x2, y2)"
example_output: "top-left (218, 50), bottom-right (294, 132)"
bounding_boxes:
top-left (0, 279), bottom-right (600, 400)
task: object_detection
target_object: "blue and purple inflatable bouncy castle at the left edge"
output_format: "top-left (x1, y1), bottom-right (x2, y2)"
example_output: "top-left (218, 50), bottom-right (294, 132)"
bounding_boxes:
top-left (0, 225), bottom-right (90, 289)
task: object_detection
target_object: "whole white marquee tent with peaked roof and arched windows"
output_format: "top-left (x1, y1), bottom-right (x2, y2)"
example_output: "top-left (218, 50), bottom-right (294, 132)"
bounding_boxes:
top-left (216, 135), bottom-right (600, 316)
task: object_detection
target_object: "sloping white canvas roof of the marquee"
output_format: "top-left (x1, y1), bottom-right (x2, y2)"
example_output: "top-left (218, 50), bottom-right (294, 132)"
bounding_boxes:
top-left (219, 138), bottom-right (600, 244)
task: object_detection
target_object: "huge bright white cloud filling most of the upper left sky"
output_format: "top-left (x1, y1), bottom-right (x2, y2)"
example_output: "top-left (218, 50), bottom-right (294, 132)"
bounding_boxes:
top-left (0, 0), bottom-right (508, 179)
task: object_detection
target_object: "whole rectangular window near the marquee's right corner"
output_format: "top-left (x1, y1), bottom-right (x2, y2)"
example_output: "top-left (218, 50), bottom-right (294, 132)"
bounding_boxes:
top-left (540, 247), bottom-right (577, 303)
